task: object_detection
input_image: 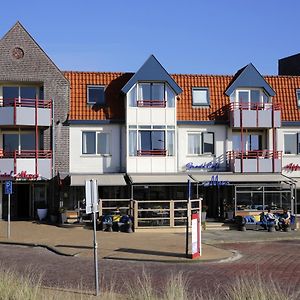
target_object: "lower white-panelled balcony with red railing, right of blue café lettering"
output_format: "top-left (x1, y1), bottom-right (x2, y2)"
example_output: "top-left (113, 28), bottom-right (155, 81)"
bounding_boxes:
top-left (226, 150), bottom-right (282, 173)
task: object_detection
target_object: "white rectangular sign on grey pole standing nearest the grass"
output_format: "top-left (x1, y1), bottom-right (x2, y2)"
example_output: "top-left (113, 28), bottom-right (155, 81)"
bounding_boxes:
top-left (85, 179), bottom-right (99, 296)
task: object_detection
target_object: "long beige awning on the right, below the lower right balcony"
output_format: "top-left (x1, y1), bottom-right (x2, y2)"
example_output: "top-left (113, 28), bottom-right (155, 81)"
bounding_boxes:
top-left (190, 172), bottom-right (292, 183)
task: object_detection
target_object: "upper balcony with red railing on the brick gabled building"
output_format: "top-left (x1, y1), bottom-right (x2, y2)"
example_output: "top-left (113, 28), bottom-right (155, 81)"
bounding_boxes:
top-left (0, 98), bottom-right (52, 127)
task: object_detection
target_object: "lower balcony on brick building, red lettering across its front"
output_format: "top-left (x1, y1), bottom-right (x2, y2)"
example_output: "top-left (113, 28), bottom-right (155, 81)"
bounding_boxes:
top-left (0, 150), bottom-right (52, 180)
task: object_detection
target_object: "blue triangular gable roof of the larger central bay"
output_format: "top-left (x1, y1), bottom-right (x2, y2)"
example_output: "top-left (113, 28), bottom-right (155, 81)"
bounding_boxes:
top-left (122, 55), bottom-right (182, 95)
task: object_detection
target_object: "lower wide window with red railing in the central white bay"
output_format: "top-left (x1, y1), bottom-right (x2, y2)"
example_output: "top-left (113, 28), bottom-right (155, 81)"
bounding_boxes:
top-left (128, 125), bottom-right (175, 156)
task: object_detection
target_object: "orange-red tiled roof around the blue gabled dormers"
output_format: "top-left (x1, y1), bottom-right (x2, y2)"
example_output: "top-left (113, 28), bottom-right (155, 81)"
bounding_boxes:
top-left (64, 72), bottom-right (300, 121)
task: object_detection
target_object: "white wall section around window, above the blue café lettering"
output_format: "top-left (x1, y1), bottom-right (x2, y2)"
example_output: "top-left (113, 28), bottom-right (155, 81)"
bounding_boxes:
top-left (177, 125), bottom-right (228, 172)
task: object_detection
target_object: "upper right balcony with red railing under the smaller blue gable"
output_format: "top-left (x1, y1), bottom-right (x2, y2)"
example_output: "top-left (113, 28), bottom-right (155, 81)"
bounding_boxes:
top-left (225, 103), bottom-right (281, 128)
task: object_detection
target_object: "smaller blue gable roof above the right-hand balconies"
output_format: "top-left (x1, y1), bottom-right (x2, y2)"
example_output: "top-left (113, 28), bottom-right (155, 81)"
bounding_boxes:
top-left (225, 63), bottom-right (275, 97)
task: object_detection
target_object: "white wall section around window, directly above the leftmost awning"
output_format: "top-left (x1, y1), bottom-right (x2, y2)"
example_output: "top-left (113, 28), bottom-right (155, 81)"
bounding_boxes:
top-left (70, 125), bottom-right (121, 174)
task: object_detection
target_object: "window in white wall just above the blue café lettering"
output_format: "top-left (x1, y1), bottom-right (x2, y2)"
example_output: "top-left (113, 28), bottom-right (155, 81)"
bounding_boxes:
top-left (188, 132), bottom-right (215, 155)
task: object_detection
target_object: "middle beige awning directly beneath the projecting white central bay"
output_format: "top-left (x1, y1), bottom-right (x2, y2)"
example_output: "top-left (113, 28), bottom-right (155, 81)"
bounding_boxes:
top-left (128, 174), bottom-right (194, 184)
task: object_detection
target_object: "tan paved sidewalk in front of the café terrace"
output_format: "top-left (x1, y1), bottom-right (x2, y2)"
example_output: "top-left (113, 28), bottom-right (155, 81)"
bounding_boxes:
top-left (0, 221), bottom-right (300, 262)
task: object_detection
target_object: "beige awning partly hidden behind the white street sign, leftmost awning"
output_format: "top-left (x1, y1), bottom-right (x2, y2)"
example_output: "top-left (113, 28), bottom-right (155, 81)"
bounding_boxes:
top-left (70, 173), bottom-right (127, 186)
